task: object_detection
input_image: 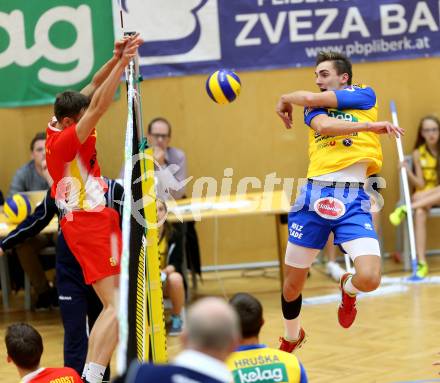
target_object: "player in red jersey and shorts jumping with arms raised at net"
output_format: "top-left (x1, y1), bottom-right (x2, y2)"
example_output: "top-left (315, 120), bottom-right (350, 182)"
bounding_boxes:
top-left (46, 34), bottom-right (142, 383)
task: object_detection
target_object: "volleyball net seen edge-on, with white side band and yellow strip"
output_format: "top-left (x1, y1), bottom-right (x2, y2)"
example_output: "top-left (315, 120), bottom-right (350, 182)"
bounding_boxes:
top-left (117, 4), bottom-right (167, 374)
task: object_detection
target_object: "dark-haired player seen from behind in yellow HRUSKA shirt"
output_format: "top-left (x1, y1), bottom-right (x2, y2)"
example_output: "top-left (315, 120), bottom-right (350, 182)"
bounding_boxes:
top-left (226, 293), bottom-right (307, 383)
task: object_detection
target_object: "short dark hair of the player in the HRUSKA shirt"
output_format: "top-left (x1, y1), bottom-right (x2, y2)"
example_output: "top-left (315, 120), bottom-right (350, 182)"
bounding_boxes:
top-left (229, 293), bottom-right (263, 338)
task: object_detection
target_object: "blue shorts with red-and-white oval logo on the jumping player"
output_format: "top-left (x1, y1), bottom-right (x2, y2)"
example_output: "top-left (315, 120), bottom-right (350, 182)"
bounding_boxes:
top-left (288, 180), bottom-right (377, 249)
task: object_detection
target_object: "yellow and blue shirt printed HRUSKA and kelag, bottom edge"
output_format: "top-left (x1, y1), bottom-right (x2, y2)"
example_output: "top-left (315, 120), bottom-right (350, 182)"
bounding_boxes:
top-left (226, 344), bottom-right (307, 383)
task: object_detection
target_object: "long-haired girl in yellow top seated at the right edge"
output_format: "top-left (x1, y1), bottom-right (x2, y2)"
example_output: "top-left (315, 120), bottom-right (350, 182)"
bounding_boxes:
top-left (390, 116), bottom-right (440, 278)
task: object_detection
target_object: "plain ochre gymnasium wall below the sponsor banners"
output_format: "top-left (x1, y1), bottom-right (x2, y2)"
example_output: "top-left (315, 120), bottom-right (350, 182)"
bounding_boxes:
top-left (0, 58), bottom-right (440, 265)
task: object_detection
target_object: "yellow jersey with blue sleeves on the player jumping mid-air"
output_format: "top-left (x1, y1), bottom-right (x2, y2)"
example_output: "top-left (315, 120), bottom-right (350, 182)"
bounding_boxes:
top-left (304, 85), bottom-right (382, 178)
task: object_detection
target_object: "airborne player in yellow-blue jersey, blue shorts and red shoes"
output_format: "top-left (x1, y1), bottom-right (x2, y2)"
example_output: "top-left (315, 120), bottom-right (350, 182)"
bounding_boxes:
top-left (277, 52), bottom-right (403, 352)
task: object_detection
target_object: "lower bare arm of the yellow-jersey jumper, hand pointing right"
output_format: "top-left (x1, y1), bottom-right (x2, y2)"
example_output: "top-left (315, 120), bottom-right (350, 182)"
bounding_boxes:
top-left (310, 114), bottom-right (404, 137)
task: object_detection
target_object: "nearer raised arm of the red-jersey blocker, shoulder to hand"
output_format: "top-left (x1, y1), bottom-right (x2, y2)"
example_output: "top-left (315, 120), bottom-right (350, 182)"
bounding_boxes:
top-left (76, 34), bottom-right (142, 143)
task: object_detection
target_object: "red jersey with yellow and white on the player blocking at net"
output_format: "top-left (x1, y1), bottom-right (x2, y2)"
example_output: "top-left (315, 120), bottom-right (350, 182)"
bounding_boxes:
top-left (46, 124), bottom-right (107, 212)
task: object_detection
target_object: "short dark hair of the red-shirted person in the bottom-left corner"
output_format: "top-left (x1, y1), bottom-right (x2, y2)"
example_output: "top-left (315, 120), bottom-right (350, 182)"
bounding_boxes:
top-left (5, 323), bottom-right (43, 370)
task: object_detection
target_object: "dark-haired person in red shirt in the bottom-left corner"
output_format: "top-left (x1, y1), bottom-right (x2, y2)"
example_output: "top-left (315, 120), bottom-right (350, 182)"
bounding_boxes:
top-left (5, 323), bottom-right (82, 383)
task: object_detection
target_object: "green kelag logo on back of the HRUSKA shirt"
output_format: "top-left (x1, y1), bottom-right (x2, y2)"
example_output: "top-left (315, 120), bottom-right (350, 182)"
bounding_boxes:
top-left (233, 363), bottom-right (288, 383)
